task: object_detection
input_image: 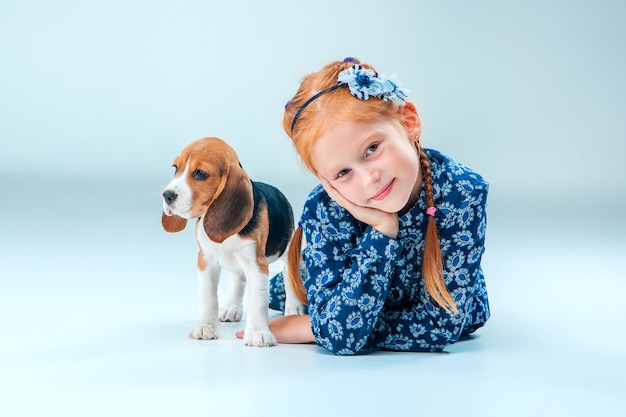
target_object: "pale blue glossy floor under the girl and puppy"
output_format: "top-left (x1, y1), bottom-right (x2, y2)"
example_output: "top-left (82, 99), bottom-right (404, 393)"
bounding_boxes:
top-left (0, 173), bottom-right (626, 417)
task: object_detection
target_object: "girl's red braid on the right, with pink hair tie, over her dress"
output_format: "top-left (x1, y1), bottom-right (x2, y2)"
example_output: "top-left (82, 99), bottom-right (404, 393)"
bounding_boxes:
top-left (416, 143), bottom-right (458, 314)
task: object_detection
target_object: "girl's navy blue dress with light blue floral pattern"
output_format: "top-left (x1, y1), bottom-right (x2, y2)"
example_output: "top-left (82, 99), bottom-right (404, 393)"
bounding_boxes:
top-left (270, 149), bottom-right (489, 355)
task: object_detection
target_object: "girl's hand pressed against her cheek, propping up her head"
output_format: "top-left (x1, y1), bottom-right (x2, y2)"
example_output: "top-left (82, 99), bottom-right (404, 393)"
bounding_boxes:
top-left (318, 176), bottom-right (399, 239)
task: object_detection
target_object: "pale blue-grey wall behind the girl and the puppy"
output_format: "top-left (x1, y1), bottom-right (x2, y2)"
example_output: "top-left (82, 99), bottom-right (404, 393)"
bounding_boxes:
top-left (0, 0), bottom-right (626, 210)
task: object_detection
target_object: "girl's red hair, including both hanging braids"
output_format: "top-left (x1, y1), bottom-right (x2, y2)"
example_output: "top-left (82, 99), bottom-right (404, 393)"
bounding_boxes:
top-left (283, 59), bottom-right (457, 313)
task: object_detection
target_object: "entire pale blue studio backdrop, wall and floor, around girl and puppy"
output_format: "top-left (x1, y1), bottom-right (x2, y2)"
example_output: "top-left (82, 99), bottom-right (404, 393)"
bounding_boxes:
top-left (0, 0), bottom-right (626, 417)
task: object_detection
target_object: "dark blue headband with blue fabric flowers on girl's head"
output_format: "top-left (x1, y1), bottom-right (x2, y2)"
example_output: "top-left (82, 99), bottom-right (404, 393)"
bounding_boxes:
top-left (285, 62), bottom-right (409, 132)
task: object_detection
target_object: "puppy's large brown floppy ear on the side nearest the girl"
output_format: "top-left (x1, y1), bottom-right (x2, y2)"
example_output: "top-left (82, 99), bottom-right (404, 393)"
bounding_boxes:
top-left (204, 165), bottom-right (254, 243)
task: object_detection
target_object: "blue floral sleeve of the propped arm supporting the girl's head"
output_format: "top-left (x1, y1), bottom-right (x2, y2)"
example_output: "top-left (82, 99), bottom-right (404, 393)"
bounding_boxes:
top-left (302, 189), bottom-right (399, 355)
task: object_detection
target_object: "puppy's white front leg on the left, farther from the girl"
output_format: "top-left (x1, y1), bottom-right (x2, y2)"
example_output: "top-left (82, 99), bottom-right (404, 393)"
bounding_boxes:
top-left (189, 263), bottom-right (220, 340)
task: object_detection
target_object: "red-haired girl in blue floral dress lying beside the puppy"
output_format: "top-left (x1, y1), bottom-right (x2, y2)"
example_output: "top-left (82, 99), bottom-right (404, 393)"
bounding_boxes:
top-left (241, 58), bottom-right (489, 355)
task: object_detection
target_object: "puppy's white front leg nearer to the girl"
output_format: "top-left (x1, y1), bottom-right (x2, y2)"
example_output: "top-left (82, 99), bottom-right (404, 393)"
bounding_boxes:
top-left (243, 262), bottom-right (277, 347)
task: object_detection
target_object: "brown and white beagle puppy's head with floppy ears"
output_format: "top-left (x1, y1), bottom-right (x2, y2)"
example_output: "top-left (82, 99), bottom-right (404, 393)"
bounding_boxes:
top-left (161, 138), bottom-right (254, 243)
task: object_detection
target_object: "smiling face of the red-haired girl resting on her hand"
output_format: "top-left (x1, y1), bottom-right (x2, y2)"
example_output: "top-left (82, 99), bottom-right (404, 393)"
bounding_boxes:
top-left (311, 121), bottom-right (421, 213)
